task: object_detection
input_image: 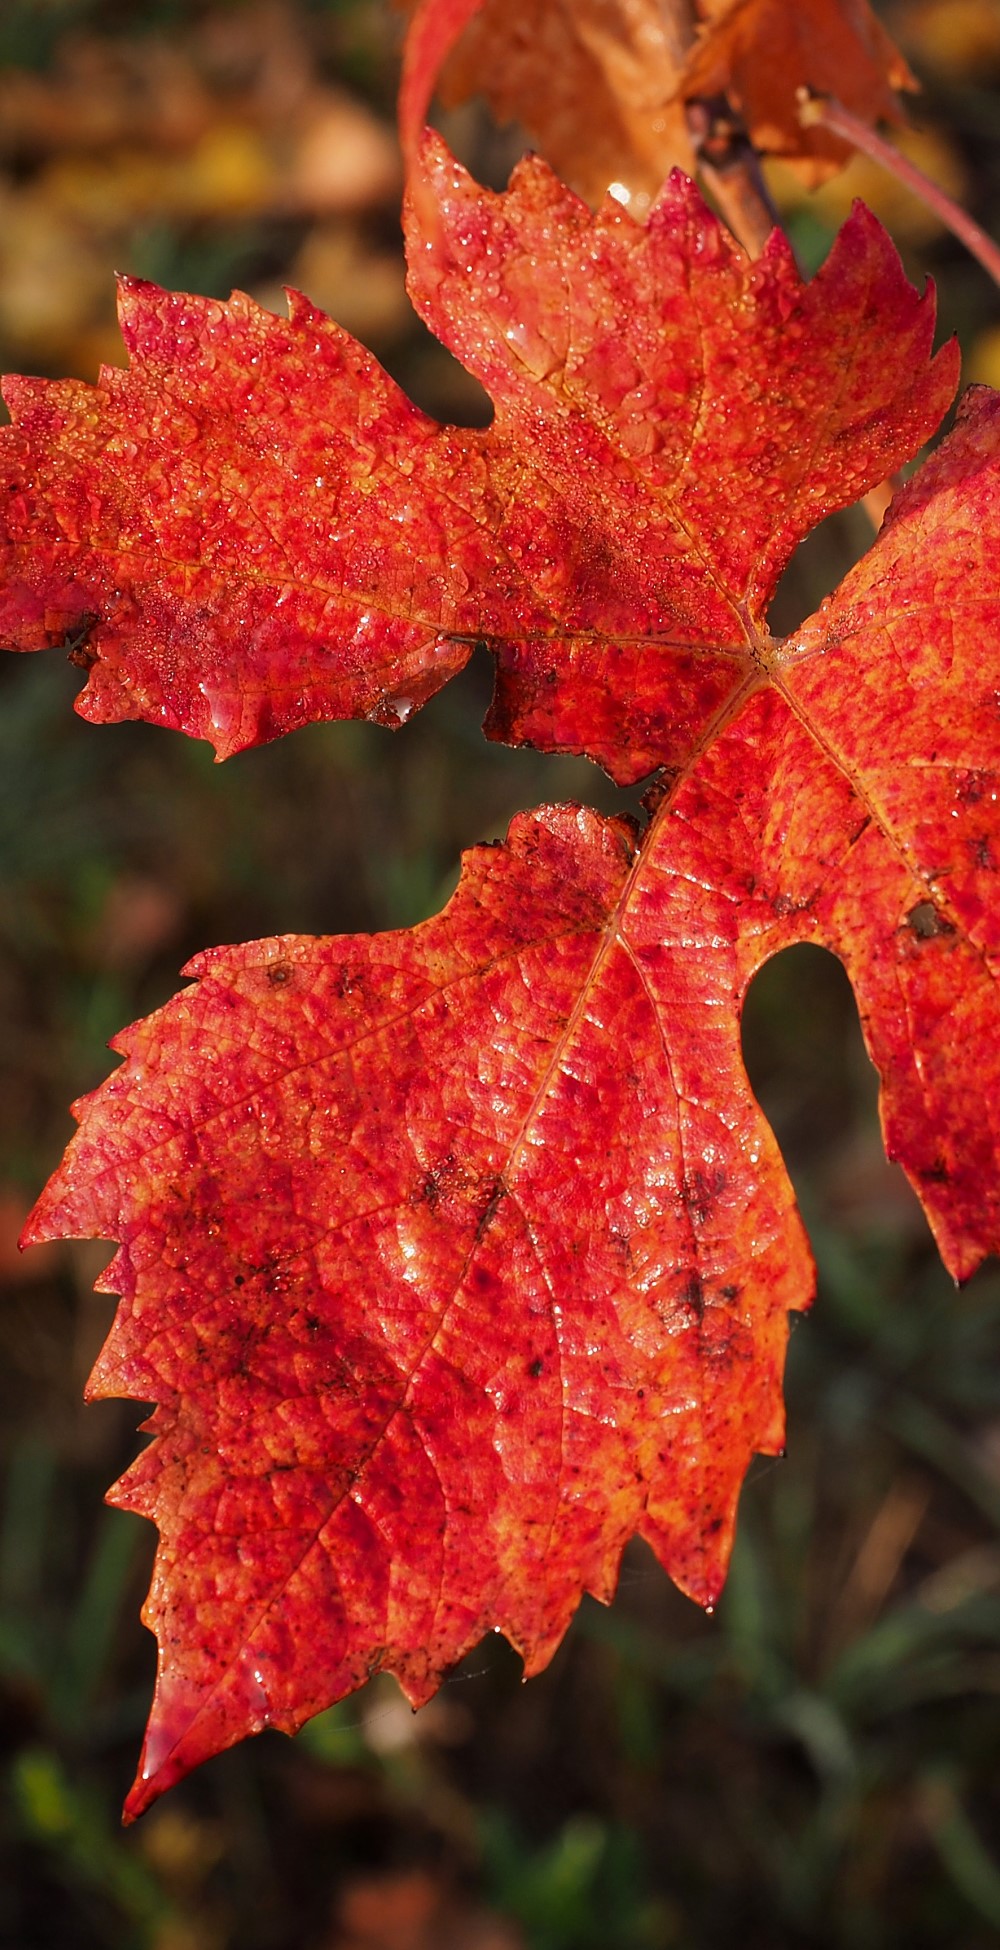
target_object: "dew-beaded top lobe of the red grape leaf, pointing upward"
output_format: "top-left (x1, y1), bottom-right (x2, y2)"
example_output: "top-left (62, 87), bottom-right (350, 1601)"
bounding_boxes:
top-left (399, 140), bottom-right (957, 784)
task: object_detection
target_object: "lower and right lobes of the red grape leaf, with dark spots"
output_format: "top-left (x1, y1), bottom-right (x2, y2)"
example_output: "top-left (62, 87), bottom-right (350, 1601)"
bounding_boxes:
top-left (27, 390), bottom-right (1000, 1814)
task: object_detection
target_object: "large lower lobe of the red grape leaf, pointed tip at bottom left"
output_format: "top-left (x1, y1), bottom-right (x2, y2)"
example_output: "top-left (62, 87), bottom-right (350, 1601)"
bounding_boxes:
top-left (29, 807), bottom-right (809, 1812)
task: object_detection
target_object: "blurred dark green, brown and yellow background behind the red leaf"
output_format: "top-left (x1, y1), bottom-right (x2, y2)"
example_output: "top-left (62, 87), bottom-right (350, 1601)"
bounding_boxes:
top-left (0, 0), bottom-right (1000, 1950)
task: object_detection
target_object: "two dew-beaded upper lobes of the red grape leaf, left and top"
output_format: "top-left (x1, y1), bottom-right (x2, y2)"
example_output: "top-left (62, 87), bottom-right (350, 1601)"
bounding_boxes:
top-left (0, 138), bottom-right (957, 780)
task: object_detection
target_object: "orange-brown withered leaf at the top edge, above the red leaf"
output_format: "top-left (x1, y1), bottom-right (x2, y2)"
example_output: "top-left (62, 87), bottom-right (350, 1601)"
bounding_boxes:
top-left (402, 0), bottom-right (916, 211)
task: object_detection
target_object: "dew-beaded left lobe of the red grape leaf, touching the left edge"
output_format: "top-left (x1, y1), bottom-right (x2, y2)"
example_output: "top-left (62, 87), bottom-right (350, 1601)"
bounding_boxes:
top-left (0, 279), bottom-right (479, 759)
